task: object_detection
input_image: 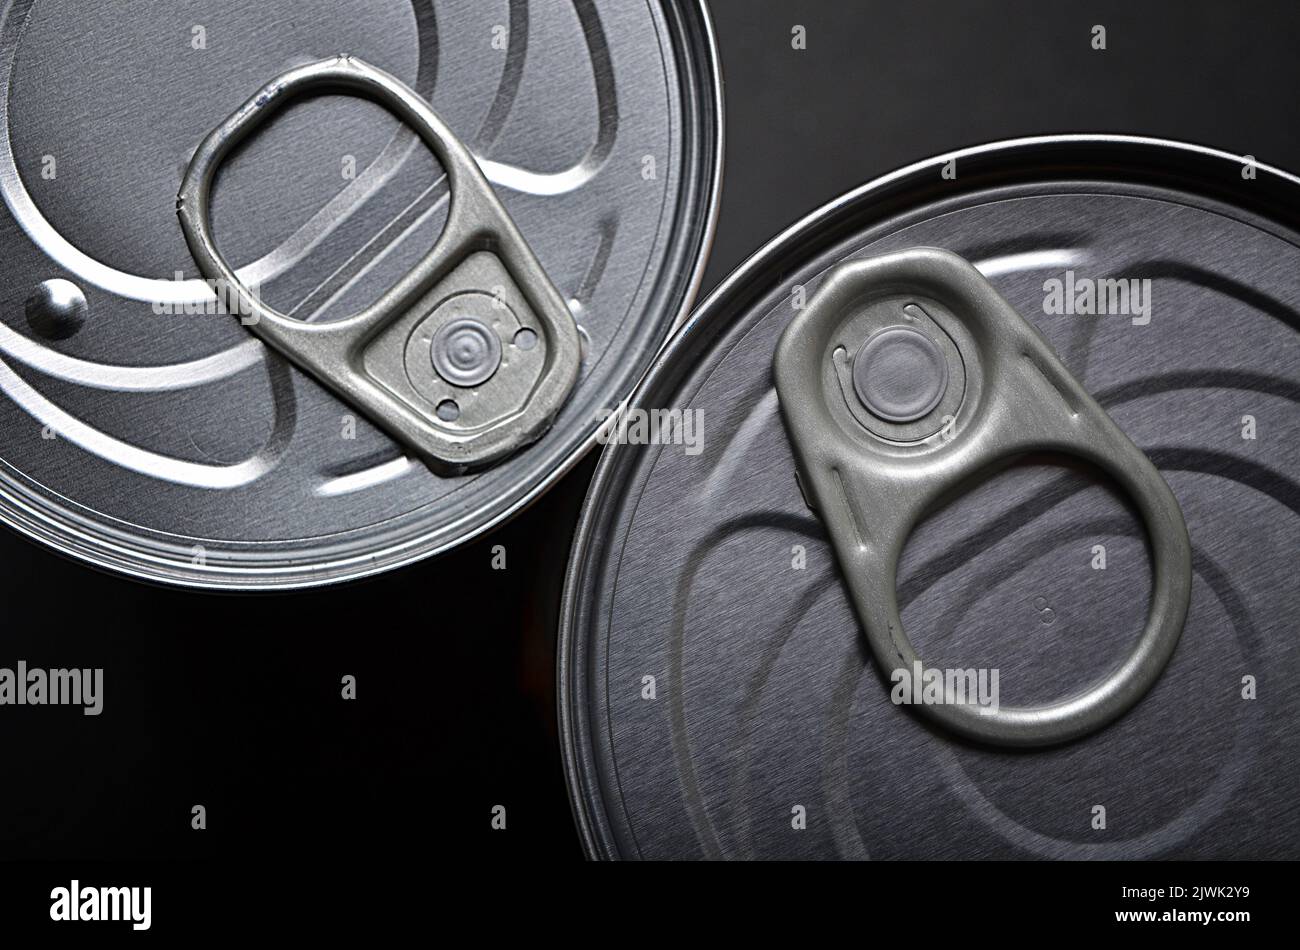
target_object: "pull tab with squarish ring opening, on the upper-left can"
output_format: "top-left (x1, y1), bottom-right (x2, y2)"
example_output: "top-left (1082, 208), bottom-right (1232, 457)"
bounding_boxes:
top-left (177, 56), bottom-right (581, 474)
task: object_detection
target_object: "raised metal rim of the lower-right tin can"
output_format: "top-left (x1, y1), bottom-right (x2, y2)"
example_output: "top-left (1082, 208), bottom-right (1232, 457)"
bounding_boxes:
top-left (556, 133), bottom-right (1300, 859)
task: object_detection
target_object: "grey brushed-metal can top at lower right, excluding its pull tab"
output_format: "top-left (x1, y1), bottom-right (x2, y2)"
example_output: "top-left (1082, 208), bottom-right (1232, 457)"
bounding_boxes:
top-left (559, 135), bottom-right (1300, 859)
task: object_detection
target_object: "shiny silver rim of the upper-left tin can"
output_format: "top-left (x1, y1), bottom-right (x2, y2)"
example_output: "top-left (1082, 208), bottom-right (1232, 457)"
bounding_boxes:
top-left (0, 0), bottom-right (725, 594)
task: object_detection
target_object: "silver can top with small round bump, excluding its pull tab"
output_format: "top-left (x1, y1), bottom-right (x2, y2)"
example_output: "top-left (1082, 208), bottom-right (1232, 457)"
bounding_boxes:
top-left (0, 0), bottom-right (722, 589)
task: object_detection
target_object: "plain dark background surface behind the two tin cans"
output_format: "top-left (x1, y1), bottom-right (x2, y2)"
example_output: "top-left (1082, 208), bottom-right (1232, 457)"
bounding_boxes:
top-left (0, 0), bottom-right (1300, 862)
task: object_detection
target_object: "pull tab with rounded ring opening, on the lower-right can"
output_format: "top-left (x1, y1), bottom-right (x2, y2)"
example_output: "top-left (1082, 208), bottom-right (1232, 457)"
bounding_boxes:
top-left (774, 248), bottom-right (1192, 746)
